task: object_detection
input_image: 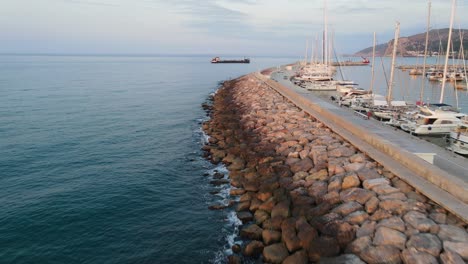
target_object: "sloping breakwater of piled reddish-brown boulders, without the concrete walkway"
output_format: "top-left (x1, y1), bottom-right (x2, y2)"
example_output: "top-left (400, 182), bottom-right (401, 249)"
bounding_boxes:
top-left (203, 75), bottom-right (468, 263)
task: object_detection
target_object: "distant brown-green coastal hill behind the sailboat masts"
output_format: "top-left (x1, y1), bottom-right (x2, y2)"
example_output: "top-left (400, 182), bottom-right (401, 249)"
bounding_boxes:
top-left (354, 28), bottom-right (468, 57)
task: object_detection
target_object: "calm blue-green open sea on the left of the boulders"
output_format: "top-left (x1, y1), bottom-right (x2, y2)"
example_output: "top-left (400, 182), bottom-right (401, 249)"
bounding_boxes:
top-left (0, 56), bottom-right (294, 263)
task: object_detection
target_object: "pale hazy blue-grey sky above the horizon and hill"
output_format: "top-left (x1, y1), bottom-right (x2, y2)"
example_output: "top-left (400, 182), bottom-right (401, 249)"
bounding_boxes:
top-left (0, 0), bottom-right (468, 56)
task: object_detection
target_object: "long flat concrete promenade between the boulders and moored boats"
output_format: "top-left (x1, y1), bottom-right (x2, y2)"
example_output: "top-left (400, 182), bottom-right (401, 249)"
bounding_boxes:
top-left (256, 71), bottom-right (468, 222)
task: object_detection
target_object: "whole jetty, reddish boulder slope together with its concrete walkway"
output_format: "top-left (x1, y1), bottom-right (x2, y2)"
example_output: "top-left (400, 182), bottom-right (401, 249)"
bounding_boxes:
top-left (203, 67), bottom-right (468, 263)
